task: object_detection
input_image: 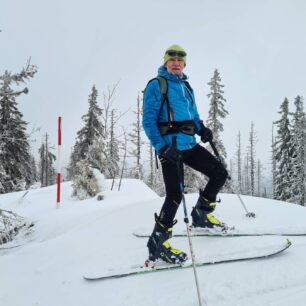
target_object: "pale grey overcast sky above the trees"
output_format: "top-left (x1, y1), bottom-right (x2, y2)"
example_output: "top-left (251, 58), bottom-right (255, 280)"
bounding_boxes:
top-left (0, 0), bottom-right (306, 178)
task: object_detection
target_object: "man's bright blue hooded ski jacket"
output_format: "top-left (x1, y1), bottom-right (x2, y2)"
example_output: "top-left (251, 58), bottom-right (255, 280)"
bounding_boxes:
top-left (142, 66), bottom-right (200, 154)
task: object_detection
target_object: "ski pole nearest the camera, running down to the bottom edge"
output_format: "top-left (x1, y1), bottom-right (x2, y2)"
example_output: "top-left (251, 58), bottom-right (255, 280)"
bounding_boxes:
top-left (172, 136), bottom-right (206, 306)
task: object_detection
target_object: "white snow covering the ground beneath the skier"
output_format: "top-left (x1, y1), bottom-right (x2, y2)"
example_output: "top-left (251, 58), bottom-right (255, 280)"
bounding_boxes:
top-left (0, 179), bottom-right (306, 306)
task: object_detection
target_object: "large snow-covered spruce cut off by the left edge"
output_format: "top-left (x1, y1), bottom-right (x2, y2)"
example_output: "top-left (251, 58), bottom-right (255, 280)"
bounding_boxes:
top-left (0, 63), bottom-right (37, 193)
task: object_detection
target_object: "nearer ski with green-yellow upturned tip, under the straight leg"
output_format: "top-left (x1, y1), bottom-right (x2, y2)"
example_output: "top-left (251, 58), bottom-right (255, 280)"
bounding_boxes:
top-left (83, 239), bottom-right (291, 281)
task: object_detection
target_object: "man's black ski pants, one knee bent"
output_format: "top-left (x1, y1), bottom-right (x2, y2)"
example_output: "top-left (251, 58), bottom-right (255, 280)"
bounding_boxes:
top-left (159, 144), bottom-right (228, 226)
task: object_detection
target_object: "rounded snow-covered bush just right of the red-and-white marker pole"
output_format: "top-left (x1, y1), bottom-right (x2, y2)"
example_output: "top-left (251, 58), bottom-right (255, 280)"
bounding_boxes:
top-left (72, 160), bottom-right (104, 200)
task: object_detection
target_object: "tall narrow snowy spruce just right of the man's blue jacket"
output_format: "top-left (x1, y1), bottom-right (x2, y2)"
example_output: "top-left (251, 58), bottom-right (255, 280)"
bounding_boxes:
top-left (206, 69), bottom-right (228, 158)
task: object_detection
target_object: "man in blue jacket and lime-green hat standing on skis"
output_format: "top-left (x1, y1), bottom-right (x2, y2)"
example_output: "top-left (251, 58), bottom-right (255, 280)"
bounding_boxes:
top-left (142, 45), bottom-right (227, 263)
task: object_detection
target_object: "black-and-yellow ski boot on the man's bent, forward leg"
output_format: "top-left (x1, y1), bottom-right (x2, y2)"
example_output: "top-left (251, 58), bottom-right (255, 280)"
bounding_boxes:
top-left (191, 191), bottom-right (228, 231)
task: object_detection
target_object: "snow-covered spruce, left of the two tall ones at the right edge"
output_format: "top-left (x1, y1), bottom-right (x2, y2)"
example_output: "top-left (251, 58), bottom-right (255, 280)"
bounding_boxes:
top-left (274, 98), bottom-right (294, 202)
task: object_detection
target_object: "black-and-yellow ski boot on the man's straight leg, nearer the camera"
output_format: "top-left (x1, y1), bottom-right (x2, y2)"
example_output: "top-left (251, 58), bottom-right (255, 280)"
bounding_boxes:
top-left (147, 214), bottom-right (187, 264)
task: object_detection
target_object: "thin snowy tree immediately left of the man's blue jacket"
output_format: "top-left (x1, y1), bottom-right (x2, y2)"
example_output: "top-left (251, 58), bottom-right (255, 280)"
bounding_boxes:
top-left (129, 95), bottom-right (144, 179)
